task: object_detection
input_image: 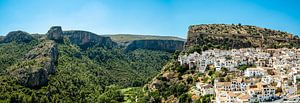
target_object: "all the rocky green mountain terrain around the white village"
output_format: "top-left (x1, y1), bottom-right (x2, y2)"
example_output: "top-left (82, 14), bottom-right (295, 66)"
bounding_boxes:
top-left (4, 24), bottom-right (300, 103)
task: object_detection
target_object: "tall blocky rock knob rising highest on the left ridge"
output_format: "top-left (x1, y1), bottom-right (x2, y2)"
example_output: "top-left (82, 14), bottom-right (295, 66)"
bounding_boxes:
top-left (47, 26), bottom-right (63, 42)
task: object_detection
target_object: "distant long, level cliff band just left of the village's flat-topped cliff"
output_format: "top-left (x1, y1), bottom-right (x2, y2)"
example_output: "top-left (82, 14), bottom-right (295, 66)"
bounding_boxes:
top-left (126, 40), bottom-right (184, 52)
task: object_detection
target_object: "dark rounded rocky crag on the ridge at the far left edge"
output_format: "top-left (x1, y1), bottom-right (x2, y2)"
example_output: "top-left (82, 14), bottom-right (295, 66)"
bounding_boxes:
top-left (2, 31), bottom-right (34, 43)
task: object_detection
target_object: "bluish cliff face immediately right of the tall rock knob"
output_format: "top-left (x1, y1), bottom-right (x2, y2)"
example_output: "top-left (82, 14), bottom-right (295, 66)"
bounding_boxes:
top-left (63, 30), bottom-right (117, 49)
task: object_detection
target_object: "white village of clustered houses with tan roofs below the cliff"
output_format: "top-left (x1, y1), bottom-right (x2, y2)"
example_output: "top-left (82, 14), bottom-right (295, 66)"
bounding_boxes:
top-left (178, 48), bottom-right (300, 103)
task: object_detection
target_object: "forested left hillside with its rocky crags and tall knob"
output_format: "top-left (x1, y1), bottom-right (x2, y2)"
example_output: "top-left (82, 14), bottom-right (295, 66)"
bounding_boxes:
top-left (0, 26), bottom-right (183, 103)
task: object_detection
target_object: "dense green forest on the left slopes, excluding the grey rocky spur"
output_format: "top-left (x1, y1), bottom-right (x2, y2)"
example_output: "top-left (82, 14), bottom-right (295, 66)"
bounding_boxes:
top-left (0, 35), bottom-right (171, 103)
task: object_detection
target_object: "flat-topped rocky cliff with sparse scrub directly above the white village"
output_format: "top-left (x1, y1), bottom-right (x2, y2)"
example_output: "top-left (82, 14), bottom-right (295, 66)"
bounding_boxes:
top-left (186, 24), bottom-right (300, 49)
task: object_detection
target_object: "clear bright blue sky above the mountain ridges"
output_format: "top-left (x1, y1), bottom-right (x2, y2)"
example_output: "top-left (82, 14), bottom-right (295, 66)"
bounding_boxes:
top-left (0, 0), bottom-right (300, 38)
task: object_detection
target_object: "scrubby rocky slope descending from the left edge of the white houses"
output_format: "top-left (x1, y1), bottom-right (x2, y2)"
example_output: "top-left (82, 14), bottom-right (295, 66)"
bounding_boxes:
top-left (130, 60), bottom-right (217, 103)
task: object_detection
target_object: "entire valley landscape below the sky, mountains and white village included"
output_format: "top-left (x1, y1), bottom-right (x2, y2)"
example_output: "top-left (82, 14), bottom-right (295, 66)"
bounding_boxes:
top-left (0, 24), bottom-right (300, 103)
